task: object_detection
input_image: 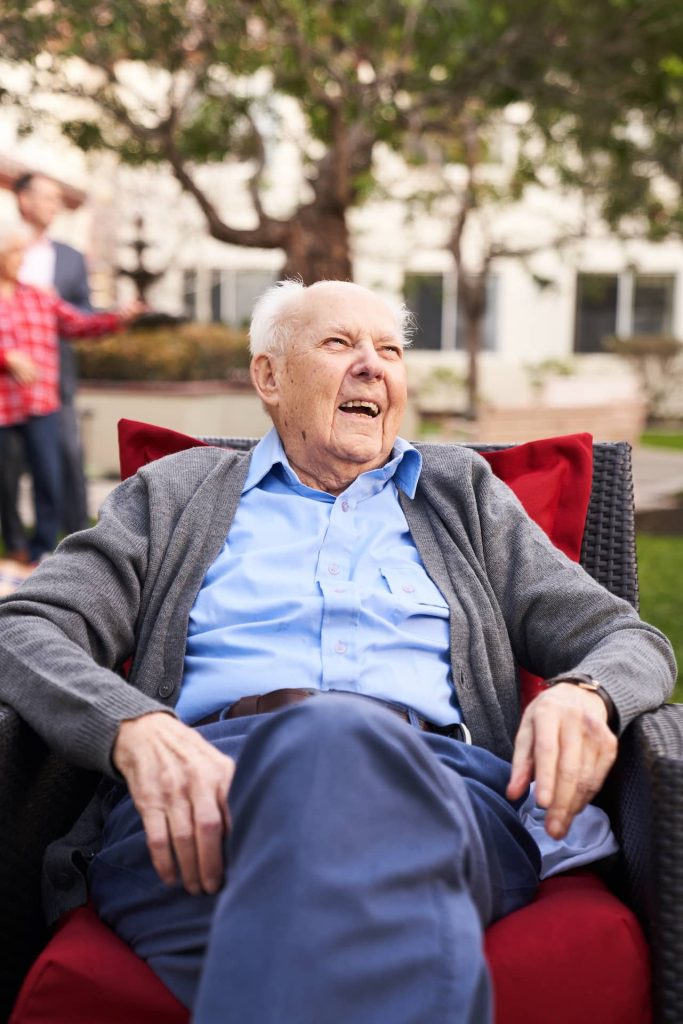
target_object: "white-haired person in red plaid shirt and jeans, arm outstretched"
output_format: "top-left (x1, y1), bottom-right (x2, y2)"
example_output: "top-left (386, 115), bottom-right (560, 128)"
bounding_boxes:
top-left (0, 222), bottom-right (143, 562)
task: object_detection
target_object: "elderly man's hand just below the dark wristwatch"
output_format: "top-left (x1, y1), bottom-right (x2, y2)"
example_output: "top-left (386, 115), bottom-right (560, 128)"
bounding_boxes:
top-left (507, 683), bottom-right (616, 839)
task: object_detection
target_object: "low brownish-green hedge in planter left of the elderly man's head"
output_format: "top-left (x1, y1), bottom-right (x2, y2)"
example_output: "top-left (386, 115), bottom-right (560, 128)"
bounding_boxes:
top-left (74, 324), bottom-right (249, 381)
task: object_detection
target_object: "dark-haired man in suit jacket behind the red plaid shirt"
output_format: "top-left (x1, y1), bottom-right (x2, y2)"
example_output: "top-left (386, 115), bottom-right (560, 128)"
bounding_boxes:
top-left (0, 174), bottom-right (92, 561)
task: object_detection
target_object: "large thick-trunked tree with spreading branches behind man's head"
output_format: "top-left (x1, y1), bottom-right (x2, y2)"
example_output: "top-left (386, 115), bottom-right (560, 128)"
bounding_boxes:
top-left (0, 0), bottom-right (426, 282)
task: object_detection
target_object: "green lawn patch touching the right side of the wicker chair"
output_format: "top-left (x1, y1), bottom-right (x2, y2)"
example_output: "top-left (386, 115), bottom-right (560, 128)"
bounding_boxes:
top-left (637, 534), bottom-right (683, 701)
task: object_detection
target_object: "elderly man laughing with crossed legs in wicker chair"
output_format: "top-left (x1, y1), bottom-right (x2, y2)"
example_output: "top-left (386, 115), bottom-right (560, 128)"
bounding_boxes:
top-left (0, 282), bottom-right (674, 1024)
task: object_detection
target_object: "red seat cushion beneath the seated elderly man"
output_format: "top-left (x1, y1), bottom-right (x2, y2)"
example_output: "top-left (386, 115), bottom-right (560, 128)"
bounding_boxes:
top-left (9, 872), bottom-right (651, 1024)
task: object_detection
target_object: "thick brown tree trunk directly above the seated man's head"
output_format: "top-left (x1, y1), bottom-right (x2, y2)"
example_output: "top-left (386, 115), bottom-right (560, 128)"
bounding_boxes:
top-left (283, 203), bottom-right (352, 285)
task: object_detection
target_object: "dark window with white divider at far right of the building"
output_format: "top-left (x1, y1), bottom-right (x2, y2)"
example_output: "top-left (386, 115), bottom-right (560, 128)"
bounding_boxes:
top-left (574, 270), bottom-right (675, 352)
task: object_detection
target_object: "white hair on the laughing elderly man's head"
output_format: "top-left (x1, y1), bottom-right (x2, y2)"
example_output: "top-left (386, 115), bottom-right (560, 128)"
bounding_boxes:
top-left (249, 281), bottom-right (415, 355)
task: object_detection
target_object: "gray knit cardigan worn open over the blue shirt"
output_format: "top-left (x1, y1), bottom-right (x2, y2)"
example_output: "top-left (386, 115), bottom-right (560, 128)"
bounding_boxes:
top-left (0, 445), bottom-right (675, 918)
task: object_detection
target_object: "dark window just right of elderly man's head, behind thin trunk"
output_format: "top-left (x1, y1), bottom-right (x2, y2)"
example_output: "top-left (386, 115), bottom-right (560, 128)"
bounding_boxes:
top-left (404, 273), bottom-right (498, 351)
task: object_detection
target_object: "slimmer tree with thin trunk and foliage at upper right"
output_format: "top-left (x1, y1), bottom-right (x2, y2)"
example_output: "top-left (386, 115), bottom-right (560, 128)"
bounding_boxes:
top-left (395, 0), bottom-right (683, 417)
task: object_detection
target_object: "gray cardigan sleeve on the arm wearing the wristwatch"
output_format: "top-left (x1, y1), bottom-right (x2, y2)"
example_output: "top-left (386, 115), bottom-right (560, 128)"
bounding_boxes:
top-left (472, 459), bottom-right (676, 731)
